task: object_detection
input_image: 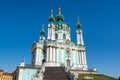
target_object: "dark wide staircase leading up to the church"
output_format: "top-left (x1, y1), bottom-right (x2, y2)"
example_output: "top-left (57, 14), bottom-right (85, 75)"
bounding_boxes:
top-left (43, 67), bottom-right (69, 80)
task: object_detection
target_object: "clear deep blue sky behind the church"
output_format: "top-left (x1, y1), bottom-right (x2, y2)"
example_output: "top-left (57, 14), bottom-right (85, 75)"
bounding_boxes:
top-left (0, 0), bottom-right (120, 77)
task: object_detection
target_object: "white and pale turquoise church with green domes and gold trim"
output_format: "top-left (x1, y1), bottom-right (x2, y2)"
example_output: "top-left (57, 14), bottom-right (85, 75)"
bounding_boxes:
top-left (14, 8), bottom-right (96, 80)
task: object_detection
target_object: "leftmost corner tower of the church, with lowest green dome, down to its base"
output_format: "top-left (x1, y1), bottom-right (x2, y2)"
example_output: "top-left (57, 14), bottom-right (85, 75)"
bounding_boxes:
top-left (32, 25), bottom-right (45, 66)
